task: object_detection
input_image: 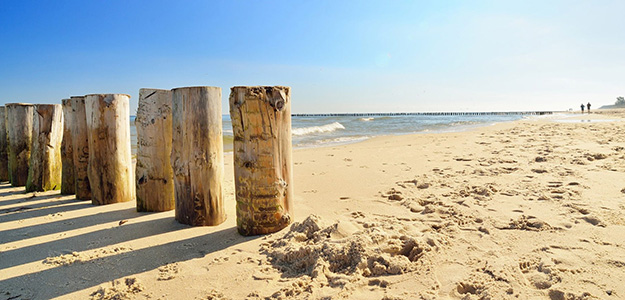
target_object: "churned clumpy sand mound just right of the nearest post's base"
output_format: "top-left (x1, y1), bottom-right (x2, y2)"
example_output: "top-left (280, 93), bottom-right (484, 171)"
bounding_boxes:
top-left (261, 215), bottom-right (437, 284)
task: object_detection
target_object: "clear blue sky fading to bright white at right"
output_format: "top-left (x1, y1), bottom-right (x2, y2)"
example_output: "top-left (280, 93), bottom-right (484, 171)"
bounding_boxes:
top-left (0, 0), bottom-right (625, 114)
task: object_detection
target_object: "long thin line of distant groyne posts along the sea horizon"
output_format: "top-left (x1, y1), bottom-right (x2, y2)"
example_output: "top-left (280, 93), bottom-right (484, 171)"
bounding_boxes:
top-left (291, 111), bottom-right (553, 117)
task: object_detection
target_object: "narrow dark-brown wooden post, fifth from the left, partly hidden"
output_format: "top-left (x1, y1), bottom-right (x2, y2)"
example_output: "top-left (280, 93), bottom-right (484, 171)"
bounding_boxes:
top-left (70, 96), bottom-right (91, 200)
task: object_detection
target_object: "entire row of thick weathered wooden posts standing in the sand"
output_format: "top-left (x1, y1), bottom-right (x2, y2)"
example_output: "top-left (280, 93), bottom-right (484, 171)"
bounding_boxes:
top-left (0, 86), bottom-right (293, 235)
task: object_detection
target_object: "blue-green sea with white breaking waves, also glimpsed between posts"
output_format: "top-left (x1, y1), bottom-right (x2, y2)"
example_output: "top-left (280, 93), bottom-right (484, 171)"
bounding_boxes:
top-left (130, 115), bottom-right (524, 155)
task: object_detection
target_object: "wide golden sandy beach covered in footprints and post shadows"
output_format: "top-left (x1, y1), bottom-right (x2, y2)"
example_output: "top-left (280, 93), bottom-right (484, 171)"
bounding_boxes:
top-left (0, 110), bottom-right (625, 300)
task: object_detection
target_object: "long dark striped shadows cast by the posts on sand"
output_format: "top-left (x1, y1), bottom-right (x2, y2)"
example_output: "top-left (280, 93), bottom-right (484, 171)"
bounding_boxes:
top-left (0, 182), bottom-right (258, 299)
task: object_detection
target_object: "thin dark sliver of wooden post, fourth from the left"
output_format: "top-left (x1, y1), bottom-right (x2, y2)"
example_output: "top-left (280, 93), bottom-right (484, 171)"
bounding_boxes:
top-left (61, 99), bottom-right (76, 195)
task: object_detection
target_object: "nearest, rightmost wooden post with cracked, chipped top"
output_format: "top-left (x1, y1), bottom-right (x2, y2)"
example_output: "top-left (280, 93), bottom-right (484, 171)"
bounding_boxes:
top-left (230, 86), bottom-right (293, 235)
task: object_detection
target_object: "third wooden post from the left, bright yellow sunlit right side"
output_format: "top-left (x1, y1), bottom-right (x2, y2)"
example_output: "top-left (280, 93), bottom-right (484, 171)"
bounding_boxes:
top-left (26, 104), bottom-right (63, 192)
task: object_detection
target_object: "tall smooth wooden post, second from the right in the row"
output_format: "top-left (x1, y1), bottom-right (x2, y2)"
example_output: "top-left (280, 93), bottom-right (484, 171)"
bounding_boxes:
top-left (171, 86), bottom-right (226, 226)
